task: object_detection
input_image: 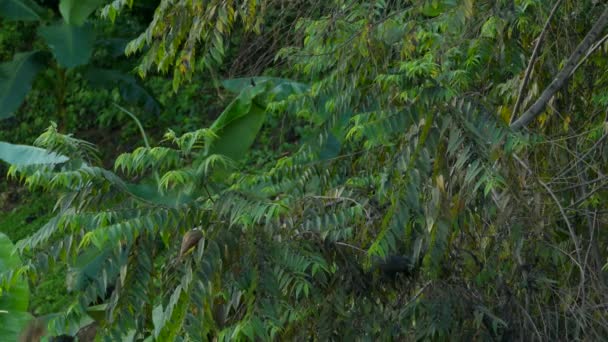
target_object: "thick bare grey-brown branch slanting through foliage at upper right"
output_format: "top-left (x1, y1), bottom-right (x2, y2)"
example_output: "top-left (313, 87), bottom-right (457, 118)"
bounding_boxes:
top-left (511, 6), bottom-right (608, 129)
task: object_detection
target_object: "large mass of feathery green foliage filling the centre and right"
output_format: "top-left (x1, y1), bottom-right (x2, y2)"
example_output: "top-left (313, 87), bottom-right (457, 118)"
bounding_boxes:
top-left (1, 0), bottom-right (608, 341)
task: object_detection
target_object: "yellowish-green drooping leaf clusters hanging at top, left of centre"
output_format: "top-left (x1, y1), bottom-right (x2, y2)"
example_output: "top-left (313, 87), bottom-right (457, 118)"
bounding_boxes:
top-left (102, 0), bottom-right (263, 90)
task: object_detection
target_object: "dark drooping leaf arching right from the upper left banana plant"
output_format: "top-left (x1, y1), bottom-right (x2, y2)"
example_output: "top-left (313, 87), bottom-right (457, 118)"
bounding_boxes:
top-left (84, 68), bottom-right (161, 114)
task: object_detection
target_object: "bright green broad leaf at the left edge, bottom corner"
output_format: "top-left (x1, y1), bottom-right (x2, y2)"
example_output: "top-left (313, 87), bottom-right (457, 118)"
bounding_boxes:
top-left (0, 233), bottom-right (32, 341)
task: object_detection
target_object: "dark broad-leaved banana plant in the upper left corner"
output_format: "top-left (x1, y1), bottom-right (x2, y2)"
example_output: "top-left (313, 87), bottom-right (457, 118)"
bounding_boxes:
top-left (0, 0), bottom-right (159, 120)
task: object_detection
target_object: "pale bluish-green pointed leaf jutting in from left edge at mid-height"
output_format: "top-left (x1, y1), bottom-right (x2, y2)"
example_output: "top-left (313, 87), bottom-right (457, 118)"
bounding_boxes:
top-left (0, 141), bottom-right (68, 166)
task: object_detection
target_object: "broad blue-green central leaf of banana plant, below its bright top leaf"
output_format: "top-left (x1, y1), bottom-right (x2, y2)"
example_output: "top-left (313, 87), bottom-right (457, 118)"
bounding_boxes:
top-left (38, 23), bottom-right (95, 68)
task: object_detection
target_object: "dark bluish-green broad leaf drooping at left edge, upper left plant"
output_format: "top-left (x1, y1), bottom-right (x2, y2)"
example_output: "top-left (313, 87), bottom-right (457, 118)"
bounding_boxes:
top-left (0, 51), bottom-right (45, 120)
